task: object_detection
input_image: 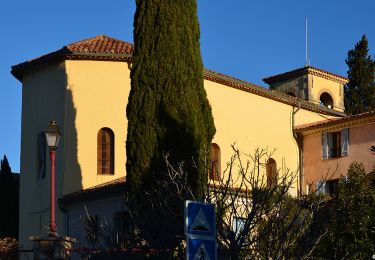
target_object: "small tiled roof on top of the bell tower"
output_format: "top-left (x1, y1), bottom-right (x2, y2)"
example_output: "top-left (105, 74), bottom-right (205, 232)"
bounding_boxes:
top-left (263, 66), bottom-right (348, 84)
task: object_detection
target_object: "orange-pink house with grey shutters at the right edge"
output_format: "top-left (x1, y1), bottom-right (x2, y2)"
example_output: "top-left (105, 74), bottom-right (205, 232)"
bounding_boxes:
top-left (295, 111), bottom-right (375, 195)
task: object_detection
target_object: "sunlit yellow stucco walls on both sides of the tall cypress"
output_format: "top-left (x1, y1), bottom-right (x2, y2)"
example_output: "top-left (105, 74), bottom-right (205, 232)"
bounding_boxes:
top-left (63, 60), bottom-right (340, 194)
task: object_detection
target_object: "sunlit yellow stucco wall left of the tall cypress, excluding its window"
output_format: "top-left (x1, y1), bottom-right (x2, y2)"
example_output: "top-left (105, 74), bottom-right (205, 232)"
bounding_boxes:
top-left (64, 60), bottom-right (130, 194)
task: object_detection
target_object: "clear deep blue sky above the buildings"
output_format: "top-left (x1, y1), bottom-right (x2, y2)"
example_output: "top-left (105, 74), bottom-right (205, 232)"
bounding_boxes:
top-left (0, 0), bottom-right (375, 172)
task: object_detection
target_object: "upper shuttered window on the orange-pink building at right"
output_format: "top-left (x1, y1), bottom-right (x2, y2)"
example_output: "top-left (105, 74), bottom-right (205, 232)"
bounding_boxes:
top-left (322, 129), bottom-right (349, 160)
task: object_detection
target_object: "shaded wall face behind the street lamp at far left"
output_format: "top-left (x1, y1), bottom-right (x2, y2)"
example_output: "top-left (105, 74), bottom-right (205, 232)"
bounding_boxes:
top-left (19, 63), bottom-right (82, 258)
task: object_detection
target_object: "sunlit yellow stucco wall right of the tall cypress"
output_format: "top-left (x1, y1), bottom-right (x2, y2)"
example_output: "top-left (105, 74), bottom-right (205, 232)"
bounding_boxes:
top-left (204, 80), bottom-right (338, 194)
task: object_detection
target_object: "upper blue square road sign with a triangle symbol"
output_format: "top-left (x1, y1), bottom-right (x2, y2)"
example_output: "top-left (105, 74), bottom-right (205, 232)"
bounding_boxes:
top-left (185, 200), bottom-right (216, 239)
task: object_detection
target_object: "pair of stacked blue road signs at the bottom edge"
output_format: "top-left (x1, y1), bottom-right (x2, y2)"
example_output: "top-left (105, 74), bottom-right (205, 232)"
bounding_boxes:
top-left (185, 200), bottom-right (217, 260)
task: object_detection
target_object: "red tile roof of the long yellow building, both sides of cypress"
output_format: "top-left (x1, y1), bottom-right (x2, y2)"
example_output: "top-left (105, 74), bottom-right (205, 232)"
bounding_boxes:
top-left (11, 35), bottom-right (345, 116)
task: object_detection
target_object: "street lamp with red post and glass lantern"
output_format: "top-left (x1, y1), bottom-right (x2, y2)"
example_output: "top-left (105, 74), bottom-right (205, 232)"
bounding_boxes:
top-left (46, 121), bottom-right (61, 235)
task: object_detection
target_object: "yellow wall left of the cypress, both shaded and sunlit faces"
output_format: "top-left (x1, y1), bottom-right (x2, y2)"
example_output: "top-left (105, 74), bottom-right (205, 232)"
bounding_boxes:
top-left (19, 60), bottom-right (130, 249)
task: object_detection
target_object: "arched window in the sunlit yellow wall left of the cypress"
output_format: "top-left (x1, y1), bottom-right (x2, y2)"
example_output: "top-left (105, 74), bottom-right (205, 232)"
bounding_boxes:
top-left (98, 128), bottom-right (115, 174)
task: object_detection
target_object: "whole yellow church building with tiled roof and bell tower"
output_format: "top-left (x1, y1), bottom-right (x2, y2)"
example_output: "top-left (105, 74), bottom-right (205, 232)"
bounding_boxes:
top-left (11, 35), bottom-right (347, 254)
